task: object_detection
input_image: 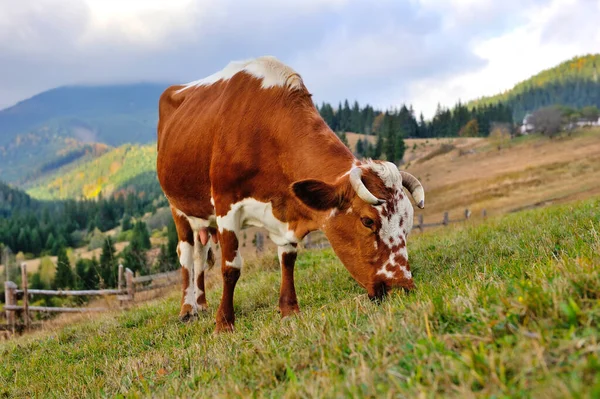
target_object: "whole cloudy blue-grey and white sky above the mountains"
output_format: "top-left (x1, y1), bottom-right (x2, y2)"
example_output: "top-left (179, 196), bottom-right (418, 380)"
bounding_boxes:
top-left (0, 0), bottom-right (600, 118)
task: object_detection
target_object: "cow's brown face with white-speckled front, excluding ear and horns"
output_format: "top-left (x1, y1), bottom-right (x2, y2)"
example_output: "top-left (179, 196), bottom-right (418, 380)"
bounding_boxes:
top-left (326, 161), bottom-right (414, 298)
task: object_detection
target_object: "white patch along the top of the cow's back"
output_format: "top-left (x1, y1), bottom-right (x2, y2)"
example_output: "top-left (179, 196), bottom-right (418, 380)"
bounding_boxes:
top-left (178, 56), bottom-right (303, 92)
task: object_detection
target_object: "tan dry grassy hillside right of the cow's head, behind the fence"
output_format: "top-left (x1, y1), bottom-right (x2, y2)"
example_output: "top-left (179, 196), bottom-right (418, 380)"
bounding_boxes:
top-left (402, 128), bottom-right (600, 223)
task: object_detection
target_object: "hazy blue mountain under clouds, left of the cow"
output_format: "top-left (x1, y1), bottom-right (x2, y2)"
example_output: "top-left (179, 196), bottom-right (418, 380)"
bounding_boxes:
top-left (0, 83), bottom-right (167, 184)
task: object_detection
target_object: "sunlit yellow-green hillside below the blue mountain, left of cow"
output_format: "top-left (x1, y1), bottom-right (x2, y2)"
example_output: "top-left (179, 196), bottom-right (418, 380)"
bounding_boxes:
top-left (27, 144), bottom-right (156, 199)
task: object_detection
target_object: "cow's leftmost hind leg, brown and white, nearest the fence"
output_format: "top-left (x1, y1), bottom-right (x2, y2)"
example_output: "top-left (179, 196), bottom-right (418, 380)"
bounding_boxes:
top-left (171, 208), bottom-right (198, 321)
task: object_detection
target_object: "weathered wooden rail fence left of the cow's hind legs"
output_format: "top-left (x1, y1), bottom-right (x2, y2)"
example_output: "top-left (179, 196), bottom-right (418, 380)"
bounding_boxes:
top-left (4, 263), bottom-right (180, 334)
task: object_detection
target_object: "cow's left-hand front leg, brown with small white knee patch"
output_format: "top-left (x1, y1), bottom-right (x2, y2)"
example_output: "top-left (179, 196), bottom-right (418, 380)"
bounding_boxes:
top-left (216, 229), bottom-right (242, 332)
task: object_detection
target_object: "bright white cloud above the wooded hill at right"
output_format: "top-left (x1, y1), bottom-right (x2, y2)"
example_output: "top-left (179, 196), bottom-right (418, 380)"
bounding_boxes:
top-left (409, 0), bottom-right (600, 116)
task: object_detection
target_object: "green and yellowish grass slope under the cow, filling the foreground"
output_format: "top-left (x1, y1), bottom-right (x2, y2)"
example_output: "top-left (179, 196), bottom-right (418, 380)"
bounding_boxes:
top-left (0, 199), bottom-right (600, 398)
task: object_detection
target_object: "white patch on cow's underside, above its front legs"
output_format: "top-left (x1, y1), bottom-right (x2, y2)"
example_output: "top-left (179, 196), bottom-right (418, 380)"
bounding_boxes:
top-left (217, 198), bottom-right (299, 246)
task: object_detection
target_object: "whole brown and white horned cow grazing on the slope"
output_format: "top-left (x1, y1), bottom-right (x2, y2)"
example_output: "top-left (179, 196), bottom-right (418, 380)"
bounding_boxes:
top-left (157, 57), bottom-right (424, 331)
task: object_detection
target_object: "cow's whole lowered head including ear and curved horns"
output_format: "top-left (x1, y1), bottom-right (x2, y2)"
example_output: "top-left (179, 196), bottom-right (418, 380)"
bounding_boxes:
top-left (292, 161), bottom-right (425, 299)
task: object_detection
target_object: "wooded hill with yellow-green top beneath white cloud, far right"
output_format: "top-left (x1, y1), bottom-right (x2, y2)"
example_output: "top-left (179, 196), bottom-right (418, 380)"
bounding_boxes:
top-left (468, 54), bottom-right (600, 122)
